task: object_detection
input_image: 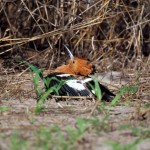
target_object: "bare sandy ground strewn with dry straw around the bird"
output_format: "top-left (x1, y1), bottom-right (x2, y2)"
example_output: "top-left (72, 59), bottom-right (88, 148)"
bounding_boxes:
top-left (0, 74), bottom-right (150, 150)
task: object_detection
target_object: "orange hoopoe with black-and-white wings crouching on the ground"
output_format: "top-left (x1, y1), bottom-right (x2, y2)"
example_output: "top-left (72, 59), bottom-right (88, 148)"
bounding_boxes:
top-left (45, 46), bottom-right (115, 101)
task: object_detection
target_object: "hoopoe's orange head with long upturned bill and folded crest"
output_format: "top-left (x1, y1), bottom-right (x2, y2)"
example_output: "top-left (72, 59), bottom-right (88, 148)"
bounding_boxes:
top-left (65, 46), bottom-right (95, 76)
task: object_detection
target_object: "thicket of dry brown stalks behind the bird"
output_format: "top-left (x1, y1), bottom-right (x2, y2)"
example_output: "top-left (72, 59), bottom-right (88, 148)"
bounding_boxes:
top-left (0, 0), bottom-right (150, 71)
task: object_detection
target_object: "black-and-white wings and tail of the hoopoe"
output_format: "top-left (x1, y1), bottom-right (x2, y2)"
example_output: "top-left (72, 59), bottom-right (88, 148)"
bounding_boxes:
top-left (46, 73), bottom-right (115, 101)
